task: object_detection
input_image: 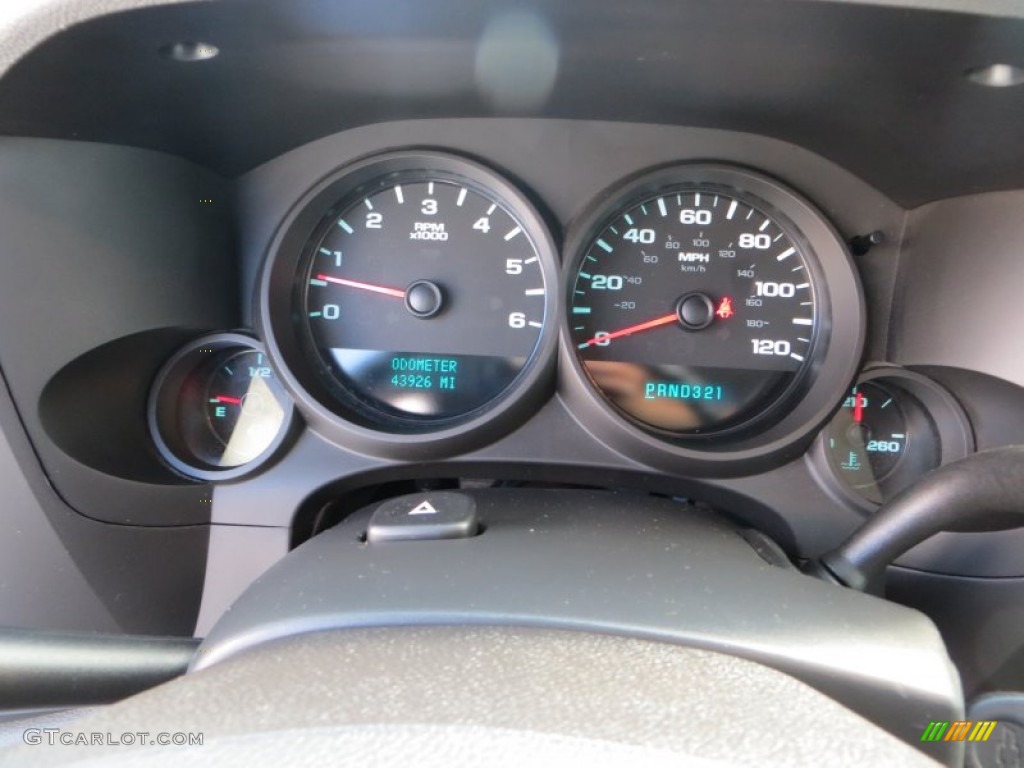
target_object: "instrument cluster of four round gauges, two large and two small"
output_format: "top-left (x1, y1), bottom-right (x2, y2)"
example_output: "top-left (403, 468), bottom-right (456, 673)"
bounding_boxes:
top-left (150, 150), bottom-right (963, 512)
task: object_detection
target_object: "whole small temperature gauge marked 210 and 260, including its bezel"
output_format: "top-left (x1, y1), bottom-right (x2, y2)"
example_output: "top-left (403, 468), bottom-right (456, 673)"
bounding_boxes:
top-left (812, 368), bottom-right (972, 507)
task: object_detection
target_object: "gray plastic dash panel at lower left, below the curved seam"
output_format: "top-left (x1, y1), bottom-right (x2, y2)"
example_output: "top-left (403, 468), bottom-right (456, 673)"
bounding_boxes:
top-left (0, 360), bottom-right (207, 635)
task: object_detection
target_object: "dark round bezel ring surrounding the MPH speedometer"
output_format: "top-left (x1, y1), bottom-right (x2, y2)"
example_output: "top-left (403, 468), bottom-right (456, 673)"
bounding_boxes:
top-left (559, 163), bottom-right (865, 476)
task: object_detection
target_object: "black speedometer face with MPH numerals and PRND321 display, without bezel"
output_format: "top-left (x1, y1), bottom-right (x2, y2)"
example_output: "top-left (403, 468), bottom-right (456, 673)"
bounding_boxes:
top-left (568, 183), bottom-right (824, 438)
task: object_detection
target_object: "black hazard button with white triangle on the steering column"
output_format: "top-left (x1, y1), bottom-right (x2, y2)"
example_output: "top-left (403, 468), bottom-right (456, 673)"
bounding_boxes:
top-left (367, 490), bottom-right (479, 544)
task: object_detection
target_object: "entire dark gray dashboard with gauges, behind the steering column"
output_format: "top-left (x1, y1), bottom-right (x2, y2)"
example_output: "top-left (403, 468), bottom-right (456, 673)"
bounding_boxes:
top-left (0, 0), bottom-right (1024, 745)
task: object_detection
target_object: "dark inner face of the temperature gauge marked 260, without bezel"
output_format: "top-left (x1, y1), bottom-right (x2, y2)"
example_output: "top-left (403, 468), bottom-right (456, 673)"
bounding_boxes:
top-left (823, 380), bottom-right (941, 504)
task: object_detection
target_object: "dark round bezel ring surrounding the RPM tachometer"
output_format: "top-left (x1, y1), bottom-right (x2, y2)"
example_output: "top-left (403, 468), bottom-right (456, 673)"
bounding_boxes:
top-left (257, 148), bottom-right (561, 460)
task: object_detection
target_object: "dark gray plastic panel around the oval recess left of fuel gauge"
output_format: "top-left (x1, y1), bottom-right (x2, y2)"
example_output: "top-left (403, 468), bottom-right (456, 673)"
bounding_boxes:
top-left (0, 137), bottom-right (238, 525)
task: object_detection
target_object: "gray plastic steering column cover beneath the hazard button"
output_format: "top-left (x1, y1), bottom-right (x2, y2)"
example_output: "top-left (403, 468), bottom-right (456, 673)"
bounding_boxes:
top-left (194, 490), bottom-right (963, 765)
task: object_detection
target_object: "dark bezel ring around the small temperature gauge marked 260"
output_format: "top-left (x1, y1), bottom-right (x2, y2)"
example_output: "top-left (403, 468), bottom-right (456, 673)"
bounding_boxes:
top-left (806, 365), bottom-right (975, 514)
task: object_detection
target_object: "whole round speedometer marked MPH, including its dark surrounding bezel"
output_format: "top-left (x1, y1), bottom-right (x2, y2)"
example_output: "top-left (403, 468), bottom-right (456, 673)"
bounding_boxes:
top-left (566, 165), bottom-right (861, 468)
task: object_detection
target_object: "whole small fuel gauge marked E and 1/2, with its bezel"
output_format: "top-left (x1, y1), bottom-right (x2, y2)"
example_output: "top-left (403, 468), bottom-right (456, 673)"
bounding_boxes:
top-left (150, 334), bottom-right (292, 479)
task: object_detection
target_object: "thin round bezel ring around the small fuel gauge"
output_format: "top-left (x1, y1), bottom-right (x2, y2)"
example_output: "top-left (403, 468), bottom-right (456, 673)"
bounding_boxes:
top-left (146, 333), bottom-right (297, 481)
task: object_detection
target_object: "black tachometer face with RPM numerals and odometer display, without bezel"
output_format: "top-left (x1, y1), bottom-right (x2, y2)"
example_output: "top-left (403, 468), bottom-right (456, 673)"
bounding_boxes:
top-left (295, 170), bottom-right (549, 431)
